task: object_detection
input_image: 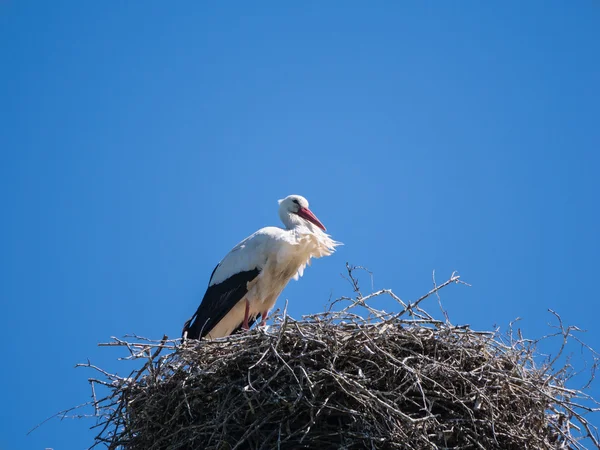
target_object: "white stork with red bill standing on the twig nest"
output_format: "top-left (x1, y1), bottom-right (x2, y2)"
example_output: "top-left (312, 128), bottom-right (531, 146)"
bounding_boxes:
top-left (182, 195), bottom-right (340, 339)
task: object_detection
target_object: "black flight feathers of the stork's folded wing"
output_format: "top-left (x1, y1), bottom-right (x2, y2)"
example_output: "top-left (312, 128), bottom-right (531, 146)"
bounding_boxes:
top-left (181, 265), bottom-right (260, 339)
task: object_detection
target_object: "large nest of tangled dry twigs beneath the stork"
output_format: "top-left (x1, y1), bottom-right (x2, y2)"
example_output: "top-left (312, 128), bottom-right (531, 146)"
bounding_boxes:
top-left (78, 273), bottom-right (598, 450)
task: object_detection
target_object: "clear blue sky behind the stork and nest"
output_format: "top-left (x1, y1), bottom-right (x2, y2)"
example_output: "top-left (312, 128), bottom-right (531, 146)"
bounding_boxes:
top-left (0, 0), bottom-right (600, 450)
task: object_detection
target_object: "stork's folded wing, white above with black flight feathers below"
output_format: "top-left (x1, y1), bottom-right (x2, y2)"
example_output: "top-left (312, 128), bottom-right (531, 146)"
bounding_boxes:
top-left (182, 227), bottom-right (280, 339)
